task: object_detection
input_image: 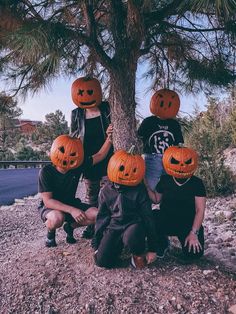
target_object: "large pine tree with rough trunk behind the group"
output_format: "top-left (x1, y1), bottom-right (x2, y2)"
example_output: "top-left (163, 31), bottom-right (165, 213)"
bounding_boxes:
top-left (0, 0), bottom-right (236, 149)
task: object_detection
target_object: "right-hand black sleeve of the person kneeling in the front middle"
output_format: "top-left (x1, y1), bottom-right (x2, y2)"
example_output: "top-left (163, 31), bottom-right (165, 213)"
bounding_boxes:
top-left (138, 186), bottom-right (157, 252)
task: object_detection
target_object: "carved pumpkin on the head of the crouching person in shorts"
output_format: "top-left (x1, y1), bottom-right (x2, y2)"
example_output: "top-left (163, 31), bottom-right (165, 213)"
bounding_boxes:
top-left (50, 135), bottom-right (84, 170)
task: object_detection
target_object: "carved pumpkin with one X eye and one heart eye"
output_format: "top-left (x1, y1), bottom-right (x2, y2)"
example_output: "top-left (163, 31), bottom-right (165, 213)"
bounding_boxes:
top-left (71, 77), bottom-right (102, 109)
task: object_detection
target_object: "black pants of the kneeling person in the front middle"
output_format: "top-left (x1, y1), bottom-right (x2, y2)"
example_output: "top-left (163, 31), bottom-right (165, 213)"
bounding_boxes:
top-left (95, 224), bottom-right (145, 268)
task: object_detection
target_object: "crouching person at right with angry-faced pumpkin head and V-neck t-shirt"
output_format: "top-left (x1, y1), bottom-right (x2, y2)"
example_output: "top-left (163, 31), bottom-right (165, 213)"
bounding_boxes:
top-left (153, 146), bottom-right (206, 260)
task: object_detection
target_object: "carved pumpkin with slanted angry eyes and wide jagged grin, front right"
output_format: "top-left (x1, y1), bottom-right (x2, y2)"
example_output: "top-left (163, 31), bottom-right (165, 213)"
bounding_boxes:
top-left (163, 146), bottom-right (198, 179)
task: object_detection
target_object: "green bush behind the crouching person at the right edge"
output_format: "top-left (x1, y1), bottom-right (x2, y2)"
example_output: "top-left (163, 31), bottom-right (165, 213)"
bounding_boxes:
top-left (186, 95), bottom-right (235, 196)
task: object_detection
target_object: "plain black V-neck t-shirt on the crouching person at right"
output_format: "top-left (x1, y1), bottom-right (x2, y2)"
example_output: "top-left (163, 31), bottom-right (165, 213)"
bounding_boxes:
top-left (156, 175), bottom-right (206, 231)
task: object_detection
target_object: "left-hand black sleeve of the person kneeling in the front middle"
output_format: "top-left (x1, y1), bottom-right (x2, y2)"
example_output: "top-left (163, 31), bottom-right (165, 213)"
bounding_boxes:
top-left (93, 191), bottom-right (111, 250)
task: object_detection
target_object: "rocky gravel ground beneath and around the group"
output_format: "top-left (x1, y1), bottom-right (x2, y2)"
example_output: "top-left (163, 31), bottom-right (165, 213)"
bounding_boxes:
top-left (0, 183), bottom-right (236, 314)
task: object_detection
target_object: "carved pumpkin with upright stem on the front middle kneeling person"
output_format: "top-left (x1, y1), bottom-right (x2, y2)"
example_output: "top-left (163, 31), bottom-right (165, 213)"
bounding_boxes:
top-left (107, 146), bottom-right (145, 186)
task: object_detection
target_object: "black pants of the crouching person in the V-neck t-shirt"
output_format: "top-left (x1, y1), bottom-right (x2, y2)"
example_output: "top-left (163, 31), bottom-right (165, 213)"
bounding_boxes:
top-left (154, 211), bottom-right (204, 260)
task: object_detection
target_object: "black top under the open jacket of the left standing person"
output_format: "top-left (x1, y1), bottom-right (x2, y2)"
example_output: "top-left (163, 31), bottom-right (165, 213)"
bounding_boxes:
top-left (83, 116), bottom-right (111, 179)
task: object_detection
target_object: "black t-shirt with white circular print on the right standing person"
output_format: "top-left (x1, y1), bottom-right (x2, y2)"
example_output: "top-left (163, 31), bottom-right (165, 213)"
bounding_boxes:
top-left (138, 116), bottom-right (184, 154)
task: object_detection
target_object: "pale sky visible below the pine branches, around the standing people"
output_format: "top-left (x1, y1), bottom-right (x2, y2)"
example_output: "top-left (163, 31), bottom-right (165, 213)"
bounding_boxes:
top-left (2, 67), bottom-right (206, 124)
